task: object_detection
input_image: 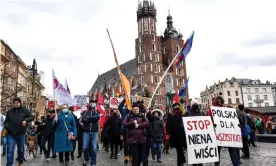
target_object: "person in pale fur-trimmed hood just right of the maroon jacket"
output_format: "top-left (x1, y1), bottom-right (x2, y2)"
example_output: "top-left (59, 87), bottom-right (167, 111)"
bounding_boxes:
top-left (150, 109), bottom-right (164, 163)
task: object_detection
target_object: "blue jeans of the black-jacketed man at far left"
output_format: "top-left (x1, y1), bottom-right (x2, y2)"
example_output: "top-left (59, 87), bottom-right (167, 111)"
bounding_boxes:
top-left (6, 135), bottom-right (25, 166)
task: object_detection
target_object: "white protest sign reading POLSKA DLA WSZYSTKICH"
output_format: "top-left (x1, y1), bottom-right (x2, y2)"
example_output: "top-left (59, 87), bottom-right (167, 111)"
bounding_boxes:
top-left (211, 106), bottom-right (243, 148)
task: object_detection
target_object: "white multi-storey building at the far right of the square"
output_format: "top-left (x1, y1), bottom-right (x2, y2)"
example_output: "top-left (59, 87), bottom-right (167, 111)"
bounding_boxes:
top-left (242, 80), bottom-right (275, 107)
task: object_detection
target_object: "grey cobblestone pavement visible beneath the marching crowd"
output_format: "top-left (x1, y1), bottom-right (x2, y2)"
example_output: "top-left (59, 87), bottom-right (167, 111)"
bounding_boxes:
top-left (1, 143), bottom-right (276, 166)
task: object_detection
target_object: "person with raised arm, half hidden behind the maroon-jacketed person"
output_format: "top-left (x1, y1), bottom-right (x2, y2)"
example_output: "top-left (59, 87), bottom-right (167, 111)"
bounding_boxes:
top-left (118, 96), bottom-right (131, 164)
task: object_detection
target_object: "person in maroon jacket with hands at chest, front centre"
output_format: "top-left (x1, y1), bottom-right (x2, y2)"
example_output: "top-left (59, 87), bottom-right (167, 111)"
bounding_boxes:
top-left (124, 103), bottom-right (149, 166)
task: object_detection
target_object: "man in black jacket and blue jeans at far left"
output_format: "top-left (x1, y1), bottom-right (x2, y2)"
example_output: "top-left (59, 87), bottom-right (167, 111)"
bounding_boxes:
top-left (4, 97), bottom-right (34, 166)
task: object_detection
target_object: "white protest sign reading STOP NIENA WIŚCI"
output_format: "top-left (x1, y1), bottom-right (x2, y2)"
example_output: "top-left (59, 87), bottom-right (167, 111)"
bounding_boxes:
top-left (182, 116), bottom-right (219, 164)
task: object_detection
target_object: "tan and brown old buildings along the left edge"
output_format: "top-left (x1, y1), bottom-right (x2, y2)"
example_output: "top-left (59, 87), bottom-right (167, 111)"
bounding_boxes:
top-left (0, 40), bottom-right (44, 112)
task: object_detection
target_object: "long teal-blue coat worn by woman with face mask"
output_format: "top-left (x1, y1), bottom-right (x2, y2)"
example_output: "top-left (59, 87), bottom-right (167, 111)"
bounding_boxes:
top-left (53, 112), bottom-right (77, 152)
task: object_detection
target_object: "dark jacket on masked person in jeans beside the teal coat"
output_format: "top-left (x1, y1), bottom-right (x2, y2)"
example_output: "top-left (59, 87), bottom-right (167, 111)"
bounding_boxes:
top-left (81, 109), bottom-right (100, 132)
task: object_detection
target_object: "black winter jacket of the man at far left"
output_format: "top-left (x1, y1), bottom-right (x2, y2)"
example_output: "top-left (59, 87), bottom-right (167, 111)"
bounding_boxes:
top-left (4, 107), bottom-right (34, 135)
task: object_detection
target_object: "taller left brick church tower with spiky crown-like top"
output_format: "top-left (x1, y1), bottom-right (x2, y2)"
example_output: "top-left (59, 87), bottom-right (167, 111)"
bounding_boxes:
top-left (135, 0), bottom-right (165, 102)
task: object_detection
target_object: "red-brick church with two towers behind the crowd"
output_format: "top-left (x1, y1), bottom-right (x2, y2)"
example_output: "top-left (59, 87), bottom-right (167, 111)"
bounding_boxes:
top-left (89, 0), bottom-right (189, 105)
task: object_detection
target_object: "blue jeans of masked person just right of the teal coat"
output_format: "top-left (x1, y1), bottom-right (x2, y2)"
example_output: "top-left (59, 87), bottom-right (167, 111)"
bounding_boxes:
top-left (83, 132), bottom-right (98, 165)
